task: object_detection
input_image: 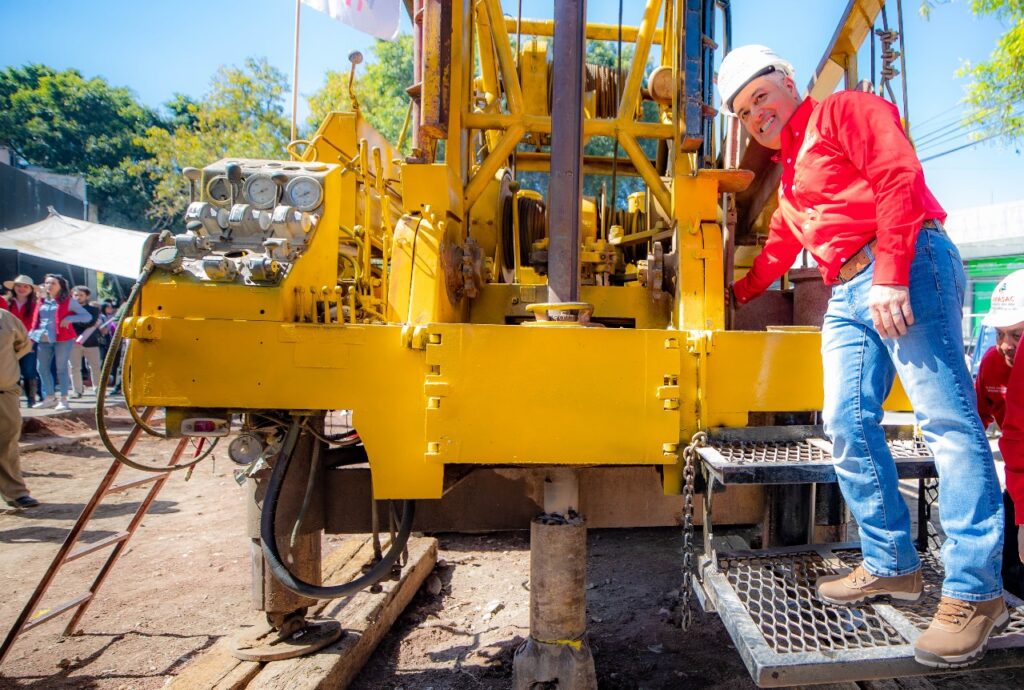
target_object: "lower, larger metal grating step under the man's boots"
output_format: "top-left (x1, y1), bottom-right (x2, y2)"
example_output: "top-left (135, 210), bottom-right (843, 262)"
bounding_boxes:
top-left (702, 544), bottom-right (1024, 687)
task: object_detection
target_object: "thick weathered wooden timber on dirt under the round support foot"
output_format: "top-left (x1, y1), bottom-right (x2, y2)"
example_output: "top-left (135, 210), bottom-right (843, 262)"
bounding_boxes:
top-left (247, 537), bottom-right (437, 690)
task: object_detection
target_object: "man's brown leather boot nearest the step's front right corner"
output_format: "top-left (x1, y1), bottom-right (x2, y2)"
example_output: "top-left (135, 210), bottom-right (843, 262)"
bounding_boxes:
top-left (913, 597), bottom-right (1010, 669)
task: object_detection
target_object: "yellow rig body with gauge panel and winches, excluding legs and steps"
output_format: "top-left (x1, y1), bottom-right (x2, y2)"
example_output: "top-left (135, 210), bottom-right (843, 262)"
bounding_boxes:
top-left (124, 0), bottom-right (906, 499)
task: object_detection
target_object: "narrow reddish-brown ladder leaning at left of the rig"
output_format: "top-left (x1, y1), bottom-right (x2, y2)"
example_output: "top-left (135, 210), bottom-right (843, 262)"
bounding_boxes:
top-left (0, 407), bottom-right (192, 664)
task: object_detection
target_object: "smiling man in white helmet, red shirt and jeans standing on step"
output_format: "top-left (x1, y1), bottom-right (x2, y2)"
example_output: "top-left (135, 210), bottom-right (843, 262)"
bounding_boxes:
top-left (718, 45), bottom-right (1009, 667)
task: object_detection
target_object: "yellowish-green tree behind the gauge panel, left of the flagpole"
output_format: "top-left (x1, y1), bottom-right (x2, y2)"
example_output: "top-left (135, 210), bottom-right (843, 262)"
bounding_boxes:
top-left (132, 57), bottom-right (290, 229)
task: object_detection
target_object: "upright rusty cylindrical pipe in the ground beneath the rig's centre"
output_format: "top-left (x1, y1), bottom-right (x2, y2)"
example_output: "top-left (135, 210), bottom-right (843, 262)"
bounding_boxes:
top-left (512, 470), bottom-right (597, 690)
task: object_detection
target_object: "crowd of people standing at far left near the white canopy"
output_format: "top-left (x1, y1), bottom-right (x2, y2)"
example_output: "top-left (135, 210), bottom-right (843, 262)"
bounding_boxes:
top-left (0, 273), bottom-right (120, 509)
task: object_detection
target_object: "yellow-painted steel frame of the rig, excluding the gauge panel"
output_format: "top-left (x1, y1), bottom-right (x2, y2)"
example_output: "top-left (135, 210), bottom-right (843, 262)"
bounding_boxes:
top-left (125, 0), bottom-right (905, 499)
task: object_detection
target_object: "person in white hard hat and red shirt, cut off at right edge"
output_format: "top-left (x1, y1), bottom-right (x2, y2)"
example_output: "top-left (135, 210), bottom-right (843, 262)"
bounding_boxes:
top-left (975, 270), bottom-right (1024, 594)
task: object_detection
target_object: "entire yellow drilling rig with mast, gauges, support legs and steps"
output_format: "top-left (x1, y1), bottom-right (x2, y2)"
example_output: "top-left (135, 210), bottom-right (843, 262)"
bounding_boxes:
top-left (88, 0), bottom-right (1024, 688)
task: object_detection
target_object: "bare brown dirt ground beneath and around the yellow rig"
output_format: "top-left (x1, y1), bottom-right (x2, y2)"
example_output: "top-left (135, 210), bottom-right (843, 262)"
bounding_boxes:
top-left (6, 411), bottom-right (1024, 690)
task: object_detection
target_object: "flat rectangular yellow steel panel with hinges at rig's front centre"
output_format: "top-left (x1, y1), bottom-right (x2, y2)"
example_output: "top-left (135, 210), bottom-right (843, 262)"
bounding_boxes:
top-left (424, 325), bottom-right (679, 465)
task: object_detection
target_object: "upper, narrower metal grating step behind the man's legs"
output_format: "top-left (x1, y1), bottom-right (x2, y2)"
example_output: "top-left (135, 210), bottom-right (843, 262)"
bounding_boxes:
top-left (697, 426), bottom-right (936, 484)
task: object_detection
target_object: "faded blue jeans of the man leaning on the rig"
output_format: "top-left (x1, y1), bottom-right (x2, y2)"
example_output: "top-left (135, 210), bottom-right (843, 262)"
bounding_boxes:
top-left (821, 228), bottom-right (1002, 601)
